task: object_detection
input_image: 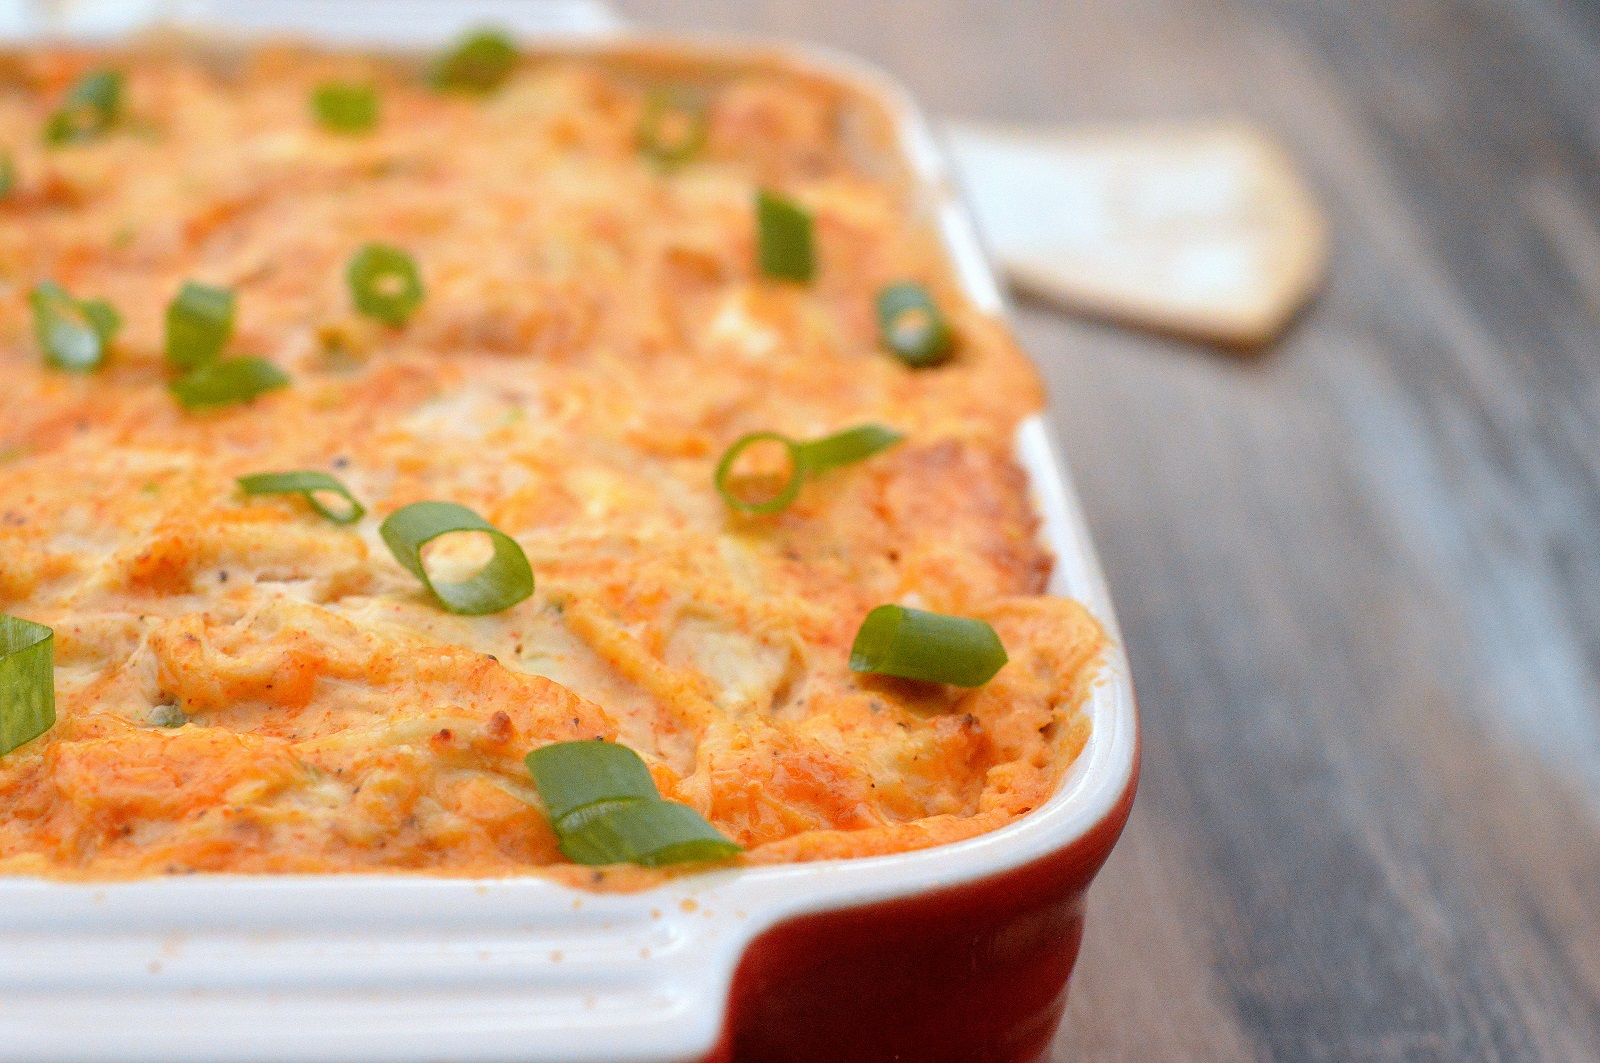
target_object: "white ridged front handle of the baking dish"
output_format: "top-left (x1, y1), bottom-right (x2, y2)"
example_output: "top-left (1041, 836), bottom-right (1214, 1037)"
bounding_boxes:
top-left (0, 871), bottom-right (758, 1063)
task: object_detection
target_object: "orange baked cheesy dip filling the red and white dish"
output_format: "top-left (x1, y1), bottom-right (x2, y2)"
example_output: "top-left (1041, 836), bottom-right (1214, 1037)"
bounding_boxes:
top-left (0, 37), bottom-right (1102, 889)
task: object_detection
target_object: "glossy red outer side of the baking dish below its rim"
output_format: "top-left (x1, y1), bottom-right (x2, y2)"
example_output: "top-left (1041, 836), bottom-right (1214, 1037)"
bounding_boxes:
top-left (704, 736), bottom-right (1139, 1063)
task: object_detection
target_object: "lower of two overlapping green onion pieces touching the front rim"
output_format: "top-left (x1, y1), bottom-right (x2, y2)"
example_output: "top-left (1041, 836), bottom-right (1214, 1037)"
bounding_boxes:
top-left (557, 800), bottom-right (741, 868)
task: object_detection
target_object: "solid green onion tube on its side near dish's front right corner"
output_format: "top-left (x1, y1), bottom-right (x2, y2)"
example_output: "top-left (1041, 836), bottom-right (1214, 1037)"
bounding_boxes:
top-left (850, 605), bottom-right (1006, 687)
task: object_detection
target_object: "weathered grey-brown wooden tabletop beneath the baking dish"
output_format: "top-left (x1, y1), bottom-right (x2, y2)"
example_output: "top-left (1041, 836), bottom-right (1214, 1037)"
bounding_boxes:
top-left (618, 0), bottom-right (1600, 1063)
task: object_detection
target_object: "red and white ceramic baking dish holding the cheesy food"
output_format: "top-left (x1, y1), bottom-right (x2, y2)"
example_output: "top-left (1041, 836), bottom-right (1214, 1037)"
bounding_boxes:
top-left (0, 5), bottom-right (1138, 1063)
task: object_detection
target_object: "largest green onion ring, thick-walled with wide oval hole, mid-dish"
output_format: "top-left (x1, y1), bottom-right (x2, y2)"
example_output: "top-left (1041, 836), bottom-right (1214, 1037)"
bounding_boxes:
top-left (378, 503), bottom-right (533, 616)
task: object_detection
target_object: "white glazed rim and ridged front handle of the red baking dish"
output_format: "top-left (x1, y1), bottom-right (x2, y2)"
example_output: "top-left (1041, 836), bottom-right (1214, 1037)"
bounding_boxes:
top-left (0, 18), bottom-right (1138, 1063)
